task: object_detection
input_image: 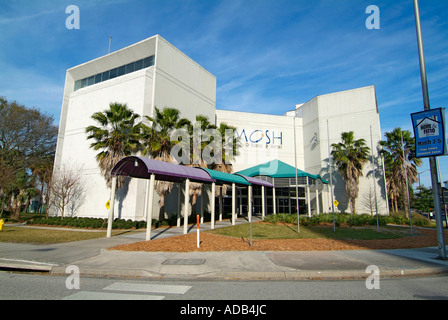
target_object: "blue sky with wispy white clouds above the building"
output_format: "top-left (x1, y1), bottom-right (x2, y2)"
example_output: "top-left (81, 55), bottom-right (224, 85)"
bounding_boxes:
top-left (0, 0), bottom-right (448, 186)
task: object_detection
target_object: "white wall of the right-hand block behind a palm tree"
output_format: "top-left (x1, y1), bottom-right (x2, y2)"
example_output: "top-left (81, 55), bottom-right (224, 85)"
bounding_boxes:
top-left (301, 86), bottom-right (388, 214)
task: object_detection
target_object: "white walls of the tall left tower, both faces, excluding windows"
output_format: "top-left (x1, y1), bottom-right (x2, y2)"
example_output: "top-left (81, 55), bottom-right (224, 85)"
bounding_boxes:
top-left (52, 36), bottom-right (216, 220)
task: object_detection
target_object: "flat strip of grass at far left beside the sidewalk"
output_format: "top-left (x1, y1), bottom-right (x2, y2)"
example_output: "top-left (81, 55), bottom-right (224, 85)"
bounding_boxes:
top-left (0, 226), bottom-right (131, 244)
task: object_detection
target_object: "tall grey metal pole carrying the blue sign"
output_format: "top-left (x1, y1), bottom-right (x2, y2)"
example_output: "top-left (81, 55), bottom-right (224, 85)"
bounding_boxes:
top-left (414, 0), bottom-right (446, 259)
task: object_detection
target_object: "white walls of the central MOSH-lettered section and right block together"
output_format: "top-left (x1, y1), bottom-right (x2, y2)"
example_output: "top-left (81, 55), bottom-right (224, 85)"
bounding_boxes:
top-left (216, 86), bottom-right (388, 214)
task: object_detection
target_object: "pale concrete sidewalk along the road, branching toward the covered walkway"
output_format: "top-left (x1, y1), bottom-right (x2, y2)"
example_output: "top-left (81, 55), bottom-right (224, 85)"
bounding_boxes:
top-left (0, 219), bottom-right (448, 280)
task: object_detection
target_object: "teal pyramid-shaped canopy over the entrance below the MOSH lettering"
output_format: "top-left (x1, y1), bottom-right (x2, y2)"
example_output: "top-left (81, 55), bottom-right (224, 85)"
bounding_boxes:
top-left (237, 160), bottom-right (328, 183)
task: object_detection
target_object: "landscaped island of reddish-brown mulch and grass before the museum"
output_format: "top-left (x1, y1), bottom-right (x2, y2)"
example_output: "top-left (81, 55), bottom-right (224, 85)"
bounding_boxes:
top-left (110, 222), bottom-right (448, 252)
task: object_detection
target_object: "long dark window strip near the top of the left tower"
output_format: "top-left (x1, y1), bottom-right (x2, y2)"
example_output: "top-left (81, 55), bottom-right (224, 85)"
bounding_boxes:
top-left (75, 56), bottom-right (154, 91)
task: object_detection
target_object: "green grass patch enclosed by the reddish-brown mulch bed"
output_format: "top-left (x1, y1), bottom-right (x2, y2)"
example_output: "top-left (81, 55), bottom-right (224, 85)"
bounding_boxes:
top-left (207, 223), bottom-right (408, 240)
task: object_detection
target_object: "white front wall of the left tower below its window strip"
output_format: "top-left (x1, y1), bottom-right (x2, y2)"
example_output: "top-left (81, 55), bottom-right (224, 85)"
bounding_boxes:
top-left (55, 68), bottom-right (152, 219)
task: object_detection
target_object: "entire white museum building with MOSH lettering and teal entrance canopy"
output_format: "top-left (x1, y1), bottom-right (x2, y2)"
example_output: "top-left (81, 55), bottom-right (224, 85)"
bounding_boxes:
top-left (53, 35), bottom-right (388, 220)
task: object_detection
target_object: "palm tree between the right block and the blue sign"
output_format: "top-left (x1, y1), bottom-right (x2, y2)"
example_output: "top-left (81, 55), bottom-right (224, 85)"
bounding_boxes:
top-left (379, 128), bottom-right (422, 214)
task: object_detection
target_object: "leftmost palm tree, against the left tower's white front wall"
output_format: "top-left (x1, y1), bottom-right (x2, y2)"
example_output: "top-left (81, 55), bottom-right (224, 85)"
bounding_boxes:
top-left (86, 102), bottom-right (140, 189)
